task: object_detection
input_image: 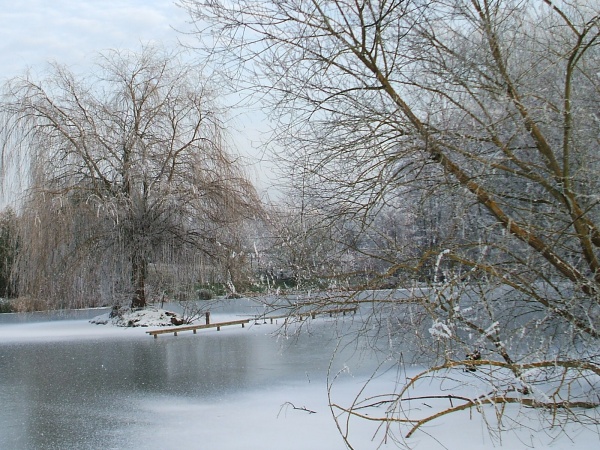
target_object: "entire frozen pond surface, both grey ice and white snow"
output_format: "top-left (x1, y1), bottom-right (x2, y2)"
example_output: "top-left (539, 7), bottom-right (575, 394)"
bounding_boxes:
top-left (0, 300), bottom-right (599, 450)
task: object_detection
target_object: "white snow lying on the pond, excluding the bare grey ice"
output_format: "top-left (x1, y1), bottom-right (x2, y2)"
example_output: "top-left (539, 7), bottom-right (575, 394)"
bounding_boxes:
top-left (0, 314), bottom-right (600, 450)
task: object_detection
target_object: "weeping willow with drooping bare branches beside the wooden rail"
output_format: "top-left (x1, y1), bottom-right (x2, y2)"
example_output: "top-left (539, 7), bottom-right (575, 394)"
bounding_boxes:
top-left (2, 47), bottom-right (258, 307)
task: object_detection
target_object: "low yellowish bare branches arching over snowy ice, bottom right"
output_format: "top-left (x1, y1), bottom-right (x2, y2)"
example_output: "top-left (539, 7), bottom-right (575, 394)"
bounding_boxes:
top-left (331, 359), bottom-right (600, 443)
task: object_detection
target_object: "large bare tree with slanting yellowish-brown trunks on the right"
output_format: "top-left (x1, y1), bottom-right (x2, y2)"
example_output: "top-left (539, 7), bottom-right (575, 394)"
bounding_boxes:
top-left (180, 0), bottom-right (600, 446)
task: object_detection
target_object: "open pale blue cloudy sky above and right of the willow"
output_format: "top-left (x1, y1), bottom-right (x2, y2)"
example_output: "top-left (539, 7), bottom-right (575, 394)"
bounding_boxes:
top-left (0, 0), bottom-right (268, 193)
